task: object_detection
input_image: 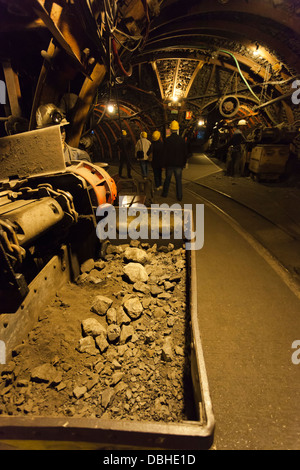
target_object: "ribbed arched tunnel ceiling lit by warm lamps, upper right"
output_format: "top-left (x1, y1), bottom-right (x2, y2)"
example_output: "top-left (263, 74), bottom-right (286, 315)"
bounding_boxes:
top-left (123, 0), bottom-right (300, 132)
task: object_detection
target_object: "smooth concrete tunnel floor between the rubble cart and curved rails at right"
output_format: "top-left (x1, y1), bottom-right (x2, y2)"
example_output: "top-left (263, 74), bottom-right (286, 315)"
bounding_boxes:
top-left (110, 155), bottom-right (300, 450)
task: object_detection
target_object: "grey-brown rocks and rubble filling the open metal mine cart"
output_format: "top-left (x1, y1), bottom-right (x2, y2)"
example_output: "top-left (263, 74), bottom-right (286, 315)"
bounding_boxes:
top-left (0, 245), bottom-right (196, 422)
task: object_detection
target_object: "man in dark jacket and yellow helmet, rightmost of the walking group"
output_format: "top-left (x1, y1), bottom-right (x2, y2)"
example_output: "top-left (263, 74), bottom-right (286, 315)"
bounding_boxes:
top-left (162, 121), bottom-right (188, 201)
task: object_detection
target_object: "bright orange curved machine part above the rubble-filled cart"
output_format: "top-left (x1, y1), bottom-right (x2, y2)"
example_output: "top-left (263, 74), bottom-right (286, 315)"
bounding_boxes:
top-left (68, 161), bottom-right (117, 205)
